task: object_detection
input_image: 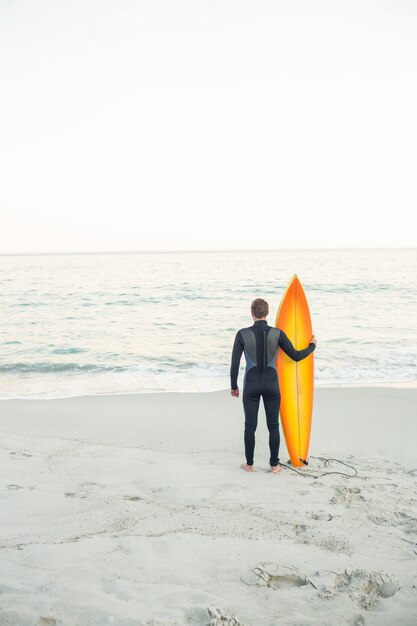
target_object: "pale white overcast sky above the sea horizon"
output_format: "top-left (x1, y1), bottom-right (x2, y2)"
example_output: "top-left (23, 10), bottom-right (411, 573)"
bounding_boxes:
top-left (0, 0), bottom-right (417, 253)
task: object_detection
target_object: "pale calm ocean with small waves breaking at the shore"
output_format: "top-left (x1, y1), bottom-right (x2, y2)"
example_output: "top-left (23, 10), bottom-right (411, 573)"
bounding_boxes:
top-left (0, 248), bottom-right (417, 398)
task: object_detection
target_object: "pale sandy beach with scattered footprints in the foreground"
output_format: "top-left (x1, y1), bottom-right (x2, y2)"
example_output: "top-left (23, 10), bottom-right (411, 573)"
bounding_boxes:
top-left (0, 386), bottom-right (417, 626)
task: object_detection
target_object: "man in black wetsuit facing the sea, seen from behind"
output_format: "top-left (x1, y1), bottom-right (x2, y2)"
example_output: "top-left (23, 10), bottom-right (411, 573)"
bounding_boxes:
top-left (230, 298), bottom-right (317, 474)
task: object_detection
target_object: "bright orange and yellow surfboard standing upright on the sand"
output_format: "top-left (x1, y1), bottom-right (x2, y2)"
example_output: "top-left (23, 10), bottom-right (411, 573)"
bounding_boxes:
top-left (275, 274), bottom-right (314, 467)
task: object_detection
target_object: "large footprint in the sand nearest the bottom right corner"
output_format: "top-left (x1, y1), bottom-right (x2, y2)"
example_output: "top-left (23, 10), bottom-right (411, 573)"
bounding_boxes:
top-left (333, 570), bottom-right (400, 610)
